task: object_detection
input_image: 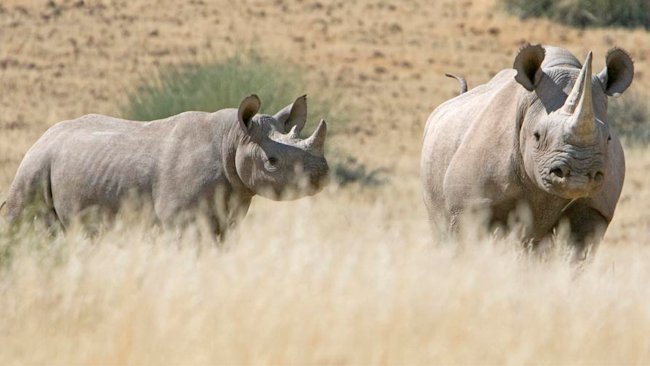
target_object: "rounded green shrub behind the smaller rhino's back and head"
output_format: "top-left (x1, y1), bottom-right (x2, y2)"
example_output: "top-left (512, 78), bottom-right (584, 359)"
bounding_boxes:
top-left (122, 54), bottom-right (344, 132)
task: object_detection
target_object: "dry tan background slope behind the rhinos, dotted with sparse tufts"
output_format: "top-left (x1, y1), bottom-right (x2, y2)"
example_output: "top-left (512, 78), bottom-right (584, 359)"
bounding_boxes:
top-left (0, 0), bottom-right (650, 183)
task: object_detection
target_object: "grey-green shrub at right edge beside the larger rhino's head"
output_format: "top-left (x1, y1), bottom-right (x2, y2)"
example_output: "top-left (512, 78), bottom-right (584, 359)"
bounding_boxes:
top-left (607, 93), bottom-right (650, 144)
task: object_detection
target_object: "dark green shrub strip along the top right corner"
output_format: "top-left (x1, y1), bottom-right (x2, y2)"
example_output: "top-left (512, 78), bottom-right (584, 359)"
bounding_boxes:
top-left (501, 0), bottom-right (650, 29)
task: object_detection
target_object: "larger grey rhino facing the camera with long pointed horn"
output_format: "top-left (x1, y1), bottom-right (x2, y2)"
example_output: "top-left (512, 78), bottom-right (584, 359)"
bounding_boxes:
top-left (420, 45), bottom-right (634, 260)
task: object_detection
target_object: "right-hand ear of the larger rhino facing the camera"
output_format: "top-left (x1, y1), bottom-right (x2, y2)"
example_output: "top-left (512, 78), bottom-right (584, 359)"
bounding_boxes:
top-left (598, 48), bottom-right (634, 97)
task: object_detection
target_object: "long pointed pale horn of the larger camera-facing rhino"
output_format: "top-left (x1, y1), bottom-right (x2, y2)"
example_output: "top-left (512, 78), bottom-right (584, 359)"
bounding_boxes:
top-left (563, 51), bottom-right (596, 143)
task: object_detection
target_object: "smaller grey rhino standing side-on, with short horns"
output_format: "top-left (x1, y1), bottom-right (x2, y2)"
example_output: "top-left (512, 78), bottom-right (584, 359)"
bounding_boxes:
top-left (4, 95), bottom-right (328, 236)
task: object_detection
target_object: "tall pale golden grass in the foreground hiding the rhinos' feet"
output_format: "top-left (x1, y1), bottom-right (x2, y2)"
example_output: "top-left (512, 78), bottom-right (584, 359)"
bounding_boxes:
top-left (0, 171), bottom-right (650, 365)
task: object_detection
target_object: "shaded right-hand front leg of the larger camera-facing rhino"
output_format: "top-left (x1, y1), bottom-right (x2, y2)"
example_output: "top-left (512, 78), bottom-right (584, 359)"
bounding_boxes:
top-left (563, 203), bottom-right (609, 262)
